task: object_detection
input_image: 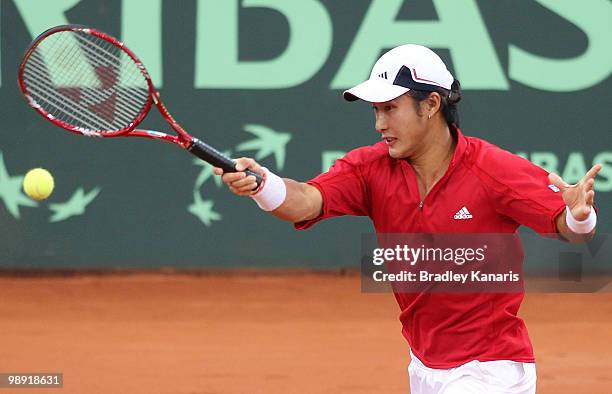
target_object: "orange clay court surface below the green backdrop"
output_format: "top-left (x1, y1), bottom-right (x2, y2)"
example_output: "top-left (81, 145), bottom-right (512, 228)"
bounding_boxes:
top-left (0, 273), bottom-right (612, 394)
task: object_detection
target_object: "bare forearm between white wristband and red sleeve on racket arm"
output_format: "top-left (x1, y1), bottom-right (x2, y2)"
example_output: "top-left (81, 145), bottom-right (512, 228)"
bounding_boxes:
top-left (270, 179), bottom-right (323, 223)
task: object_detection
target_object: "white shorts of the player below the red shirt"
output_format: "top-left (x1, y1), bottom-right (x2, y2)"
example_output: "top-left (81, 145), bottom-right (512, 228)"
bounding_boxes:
top-left (408, 352), bottom-right (536, 394)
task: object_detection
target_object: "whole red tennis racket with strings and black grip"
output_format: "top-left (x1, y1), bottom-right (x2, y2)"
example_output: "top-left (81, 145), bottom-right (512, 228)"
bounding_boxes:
top-left (19, 25), bottom-right (262, 187)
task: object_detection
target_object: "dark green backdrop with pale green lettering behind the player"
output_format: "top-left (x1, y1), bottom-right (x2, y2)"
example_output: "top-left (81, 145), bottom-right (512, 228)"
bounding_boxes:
top-left (0, 0), bottom-right (612, 268)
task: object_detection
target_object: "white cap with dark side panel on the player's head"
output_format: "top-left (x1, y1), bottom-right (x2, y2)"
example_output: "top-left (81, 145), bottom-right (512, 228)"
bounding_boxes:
top-left (343, 44), bottom-right (455, 103)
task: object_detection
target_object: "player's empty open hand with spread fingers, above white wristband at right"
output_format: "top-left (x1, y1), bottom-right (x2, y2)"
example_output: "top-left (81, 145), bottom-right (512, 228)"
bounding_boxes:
top-left (548, 164), bottom-right (602, 221)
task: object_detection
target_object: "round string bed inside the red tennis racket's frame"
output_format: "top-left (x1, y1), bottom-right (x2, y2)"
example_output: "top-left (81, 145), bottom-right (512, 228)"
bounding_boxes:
top-left (23, 31), bottom-right (149, 133)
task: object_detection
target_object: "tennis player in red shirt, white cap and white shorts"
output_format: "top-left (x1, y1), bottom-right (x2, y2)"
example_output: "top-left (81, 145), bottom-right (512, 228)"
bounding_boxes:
top-left (215, 45), bottom-right (601, 394)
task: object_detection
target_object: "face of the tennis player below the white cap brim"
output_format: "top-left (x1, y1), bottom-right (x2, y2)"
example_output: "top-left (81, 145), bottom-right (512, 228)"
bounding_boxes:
top-left (372, 94), bottom-right (427, 159)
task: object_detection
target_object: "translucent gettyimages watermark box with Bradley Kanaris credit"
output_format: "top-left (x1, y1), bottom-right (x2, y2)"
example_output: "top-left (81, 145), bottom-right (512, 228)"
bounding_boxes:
top-left (361, 233), bottom-right (612, 293)
